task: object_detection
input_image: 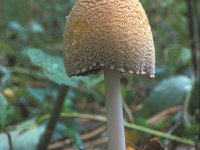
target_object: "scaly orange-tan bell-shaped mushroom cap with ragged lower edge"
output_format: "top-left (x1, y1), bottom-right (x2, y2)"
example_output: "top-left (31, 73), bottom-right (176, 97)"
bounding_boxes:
top-left (63, 0), bottom-right (155, 77)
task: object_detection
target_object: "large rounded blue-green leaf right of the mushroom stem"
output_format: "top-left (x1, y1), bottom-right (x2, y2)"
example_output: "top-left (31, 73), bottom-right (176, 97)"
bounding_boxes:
top-left (142, 76), bottom-right (193, 115)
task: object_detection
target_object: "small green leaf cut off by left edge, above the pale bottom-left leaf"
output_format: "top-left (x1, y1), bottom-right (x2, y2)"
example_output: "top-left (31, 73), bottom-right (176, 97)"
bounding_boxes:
top-left (0, 93), bottom-right (8, 126)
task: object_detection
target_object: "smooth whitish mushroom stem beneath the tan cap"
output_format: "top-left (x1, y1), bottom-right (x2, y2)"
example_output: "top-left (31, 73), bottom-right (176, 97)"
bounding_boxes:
top-left (104, 69), bottom-right (126, 150)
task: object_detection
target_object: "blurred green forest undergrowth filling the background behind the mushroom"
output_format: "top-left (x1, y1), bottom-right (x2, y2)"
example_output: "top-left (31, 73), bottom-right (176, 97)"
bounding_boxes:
top-left (0, 0), bottom-right (200, 150)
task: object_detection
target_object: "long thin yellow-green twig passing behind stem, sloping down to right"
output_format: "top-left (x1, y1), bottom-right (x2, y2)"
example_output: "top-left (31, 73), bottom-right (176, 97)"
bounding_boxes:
top-left (36, 113), bottom-right (195, 146)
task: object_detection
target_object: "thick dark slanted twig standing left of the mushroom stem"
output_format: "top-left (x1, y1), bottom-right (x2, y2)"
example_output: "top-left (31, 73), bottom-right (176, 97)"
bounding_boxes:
top-left (38, 86), bottom-right (68, 150)
